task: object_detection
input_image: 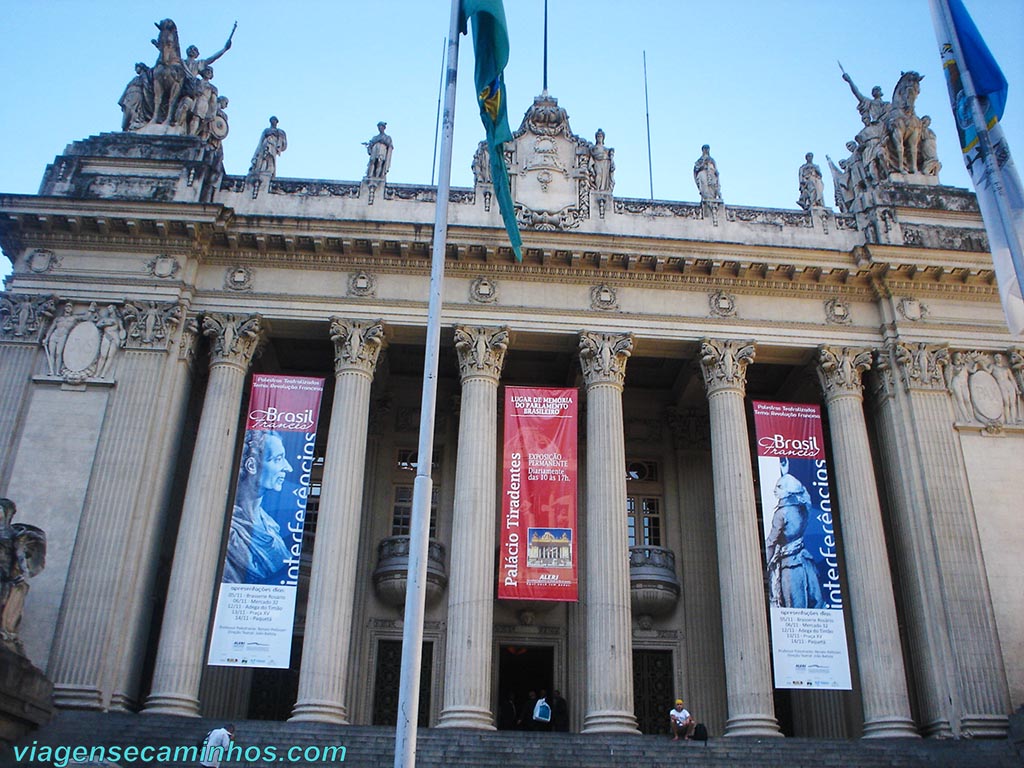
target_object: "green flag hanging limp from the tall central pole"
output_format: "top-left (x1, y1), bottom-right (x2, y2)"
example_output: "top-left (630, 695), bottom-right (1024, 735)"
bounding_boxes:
top-left (459, 0), bottom-right (522, 261)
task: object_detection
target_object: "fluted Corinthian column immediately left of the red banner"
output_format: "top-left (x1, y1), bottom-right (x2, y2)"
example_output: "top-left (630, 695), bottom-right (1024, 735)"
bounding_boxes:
top-left (437, 326), bottom-right (509, 729)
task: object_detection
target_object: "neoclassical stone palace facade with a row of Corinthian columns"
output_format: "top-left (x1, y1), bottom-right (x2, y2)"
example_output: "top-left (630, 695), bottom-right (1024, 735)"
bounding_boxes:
top-left (0, 75), bottom-right (1024, 737)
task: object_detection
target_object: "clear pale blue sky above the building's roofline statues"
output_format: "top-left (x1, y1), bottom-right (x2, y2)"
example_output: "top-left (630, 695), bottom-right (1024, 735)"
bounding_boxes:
top-left (0, 0), bottom-right (1024, 274)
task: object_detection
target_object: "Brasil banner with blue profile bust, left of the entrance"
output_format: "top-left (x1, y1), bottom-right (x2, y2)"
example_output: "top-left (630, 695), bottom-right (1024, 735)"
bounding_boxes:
top-left (209, 374), bottom-right (324, 669)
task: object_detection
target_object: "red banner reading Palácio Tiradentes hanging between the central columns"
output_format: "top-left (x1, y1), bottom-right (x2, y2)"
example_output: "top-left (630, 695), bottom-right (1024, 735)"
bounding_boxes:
top-left (498, 387), bottom-right (580, 601)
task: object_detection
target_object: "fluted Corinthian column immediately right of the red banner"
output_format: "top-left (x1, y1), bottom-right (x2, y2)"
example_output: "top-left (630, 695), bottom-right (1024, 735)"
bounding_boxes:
top-left (580, 332), bottom-right (637, 733)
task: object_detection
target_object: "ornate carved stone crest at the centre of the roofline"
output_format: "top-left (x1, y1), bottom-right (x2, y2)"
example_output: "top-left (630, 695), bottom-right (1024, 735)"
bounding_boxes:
top-left (505, 92), bottom-right (592, 230)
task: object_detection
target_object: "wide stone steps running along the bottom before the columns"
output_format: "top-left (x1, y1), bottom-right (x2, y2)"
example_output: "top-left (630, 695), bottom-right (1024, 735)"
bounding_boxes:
top-left (0, 712), bottom-right (1024, 768)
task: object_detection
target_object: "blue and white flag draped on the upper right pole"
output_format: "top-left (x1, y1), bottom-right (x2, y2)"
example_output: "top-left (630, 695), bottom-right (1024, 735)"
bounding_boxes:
top-left (932, 0), bottom-right (1024, 336)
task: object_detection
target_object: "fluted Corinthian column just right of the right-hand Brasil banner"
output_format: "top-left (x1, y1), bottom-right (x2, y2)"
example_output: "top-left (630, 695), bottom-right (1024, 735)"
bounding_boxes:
top-left (817, 346), bottom-right (918, 738)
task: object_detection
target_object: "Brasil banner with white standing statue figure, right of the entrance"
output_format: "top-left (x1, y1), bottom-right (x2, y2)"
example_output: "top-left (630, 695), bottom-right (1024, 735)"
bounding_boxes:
top-left (754, 401), bottom-right (852, 690)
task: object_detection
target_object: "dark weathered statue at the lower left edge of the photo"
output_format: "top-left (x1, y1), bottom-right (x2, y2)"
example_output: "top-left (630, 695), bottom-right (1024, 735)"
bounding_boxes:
top-left (0, 499), bottom-right (46, 655)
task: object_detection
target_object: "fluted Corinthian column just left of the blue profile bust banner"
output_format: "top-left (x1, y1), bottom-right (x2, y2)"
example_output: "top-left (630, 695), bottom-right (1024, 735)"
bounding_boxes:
top-left (144, 313), bottom-right (264, 717)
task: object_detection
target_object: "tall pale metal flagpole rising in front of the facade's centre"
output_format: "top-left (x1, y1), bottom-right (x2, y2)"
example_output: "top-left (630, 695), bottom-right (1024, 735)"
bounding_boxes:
top-left (394, 6), bottom-right (460, 768)
